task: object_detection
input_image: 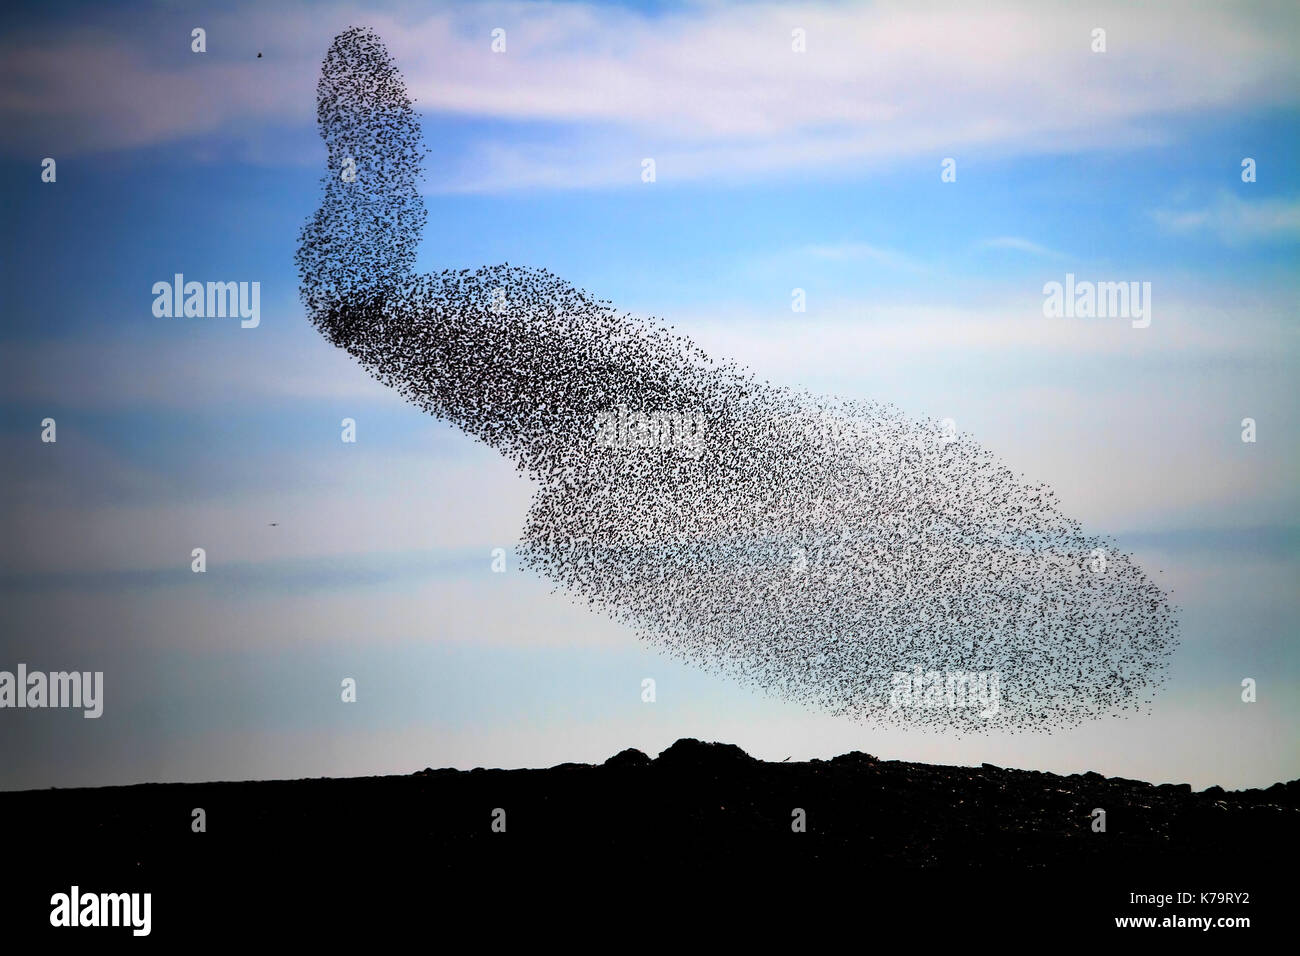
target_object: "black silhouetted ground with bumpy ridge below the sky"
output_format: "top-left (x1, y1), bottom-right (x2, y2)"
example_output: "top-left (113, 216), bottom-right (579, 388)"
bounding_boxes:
top-left (0, 740), bottom-right (1300, 942)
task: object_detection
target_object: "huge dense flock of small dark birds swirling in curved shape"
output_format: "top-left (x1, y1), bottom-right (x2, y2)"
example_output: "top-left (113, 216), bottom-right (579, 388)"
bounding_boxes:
top-left (298, 29), bottom-right (1177, 731)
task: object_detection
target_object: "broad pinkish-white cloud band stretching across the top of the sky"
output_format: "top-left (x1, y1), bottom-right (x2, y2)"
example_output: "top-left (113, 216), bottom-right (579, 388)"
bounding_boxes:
top-left (0, 3), bottom-right (1300, 193)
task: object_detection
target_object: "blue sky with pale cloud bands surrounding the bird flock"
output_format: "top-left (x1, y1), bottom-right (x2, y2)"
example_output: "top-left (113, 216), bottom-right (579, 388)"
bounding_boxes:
top-left (0, 3), bottom-right (1300, 790)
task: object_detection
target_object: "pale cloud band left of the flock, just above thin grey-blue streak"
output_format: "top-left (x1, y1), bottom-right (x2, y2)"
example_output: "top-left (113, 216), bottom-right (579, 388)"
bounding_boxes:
top-left (0, 442), bottom-right (533, 574)
